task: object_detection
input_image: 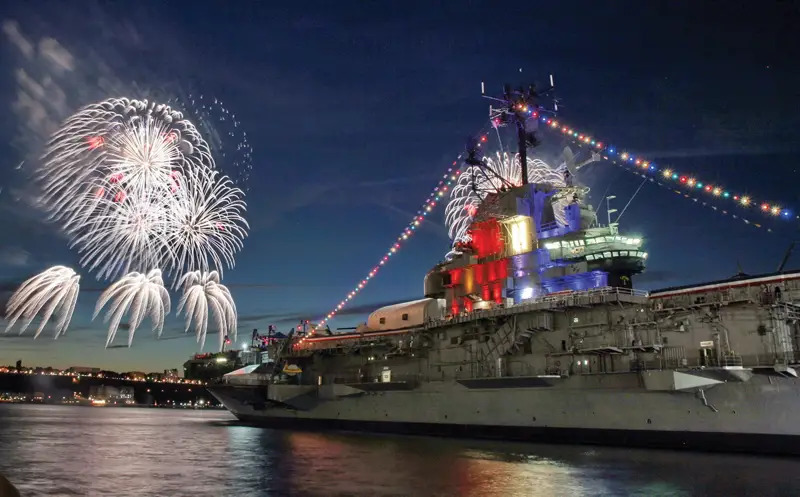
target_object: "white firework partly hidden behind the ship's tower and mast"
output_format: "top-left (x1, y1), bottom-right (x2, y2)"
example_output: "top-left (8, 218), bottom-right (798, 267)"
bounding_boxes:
top-left (445, 152), bottom-right (567, 252)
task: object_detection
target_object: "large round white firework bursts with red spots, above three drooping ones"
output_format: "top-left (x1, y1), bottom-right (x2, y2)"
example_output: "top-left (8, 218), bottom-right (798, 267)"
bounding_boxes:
top-left (36, 98), bottom-right (248, 283)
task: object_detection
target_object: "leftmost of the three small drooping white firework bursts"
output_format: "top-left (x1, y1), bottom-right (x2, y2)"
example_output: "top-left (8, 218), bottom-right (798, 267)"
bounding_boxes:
top-left (5, 266), bottom-right (81, 338)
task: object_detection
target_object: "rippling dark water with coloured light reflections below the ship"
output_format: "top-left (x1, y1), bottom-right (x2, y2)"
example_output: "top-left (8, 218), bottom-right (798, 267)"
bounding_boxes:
top-left (0, 405), bottom-right (800, 497)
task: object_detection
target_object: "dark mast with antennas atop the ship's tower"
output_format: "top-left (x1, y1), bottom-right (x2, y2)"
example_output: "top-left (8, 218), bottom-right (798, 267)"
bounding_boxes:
top-left (481, 74), bottom-right (558, 185)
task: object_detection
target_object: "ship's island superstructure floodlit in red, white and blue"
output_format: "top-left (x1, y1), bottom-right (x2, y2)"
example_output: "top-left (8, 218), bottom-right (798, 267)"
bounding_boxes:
top-left (425, 179), bottom-right (647, 315)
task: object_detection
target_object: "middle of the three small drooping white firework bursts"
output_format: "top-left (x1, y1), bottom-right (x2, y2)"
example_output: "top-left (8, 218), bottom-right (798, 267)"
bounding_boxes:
top-left (92, 269), bottom-right (170, 347)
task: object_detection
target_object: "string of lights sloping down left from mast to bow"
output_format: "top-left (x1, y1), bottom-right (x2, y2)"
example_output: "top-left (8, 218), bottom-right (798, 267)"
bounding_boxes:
top-left (298, 128), bottom-right (488, 345)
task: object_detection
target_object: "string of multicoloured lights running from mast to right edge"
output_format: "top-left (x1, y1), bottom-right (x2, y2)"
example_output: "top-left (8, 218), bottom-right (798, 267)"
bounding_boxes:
top-left (539, 116), bottom-right (800, 219)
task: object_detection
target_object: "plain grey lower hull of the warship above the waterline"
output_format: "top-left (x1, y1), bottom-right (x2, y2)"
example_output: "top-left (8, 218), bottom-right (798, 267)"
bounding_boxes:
top-left (210, 374), bottom-right (800, 455)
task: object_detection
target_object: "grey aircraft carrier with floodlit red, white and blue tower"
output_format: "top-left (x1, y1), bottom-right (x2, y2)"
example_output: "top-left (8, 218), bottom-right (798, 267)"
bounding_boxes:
top-left (209, 82), bottom-right (800, 455)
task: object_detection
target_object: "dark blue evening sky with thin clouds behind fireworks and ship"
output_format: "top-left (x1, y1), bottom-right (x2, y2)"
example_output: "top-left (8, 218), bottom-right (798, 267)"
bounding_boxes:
top-left (0, 1), bottom-right (800, 371)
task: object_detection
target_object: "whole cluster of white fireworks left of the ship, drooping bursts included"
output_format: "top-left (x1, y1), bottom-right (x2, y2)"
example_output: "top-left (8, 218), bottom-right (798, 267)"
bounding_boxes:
top-left (6, 98), bottom-right (249, 346)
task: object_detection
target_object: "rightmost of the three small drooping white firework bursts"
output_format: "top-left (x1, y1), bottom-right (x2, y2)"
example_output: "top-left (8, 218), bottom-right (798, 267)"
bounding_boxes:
top-left (178, 271), bottom-right (236, 350)
